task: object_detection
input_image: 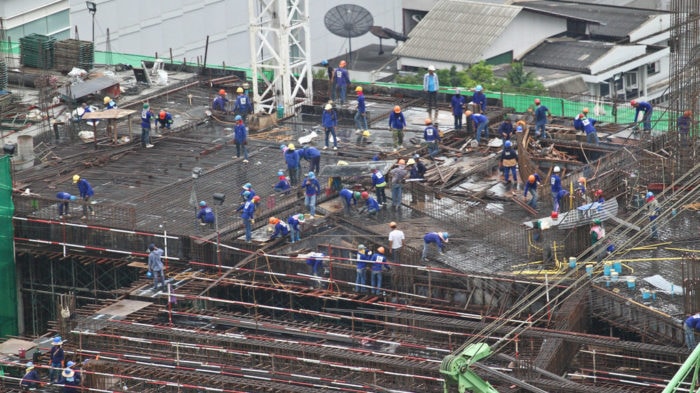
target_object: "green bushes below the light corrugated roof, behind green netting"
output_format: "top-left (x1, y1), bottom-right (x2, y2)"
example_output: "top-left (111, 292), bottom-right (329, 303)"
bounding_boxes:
top-left (395, 61), bottom-right (547, 94)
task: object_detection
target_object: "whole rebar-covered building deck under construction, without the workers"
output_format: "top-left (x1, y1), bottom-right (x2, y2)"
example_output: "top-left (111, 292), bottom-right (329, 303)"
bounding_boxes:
top-left (0, 0), bottom-right (700, 393)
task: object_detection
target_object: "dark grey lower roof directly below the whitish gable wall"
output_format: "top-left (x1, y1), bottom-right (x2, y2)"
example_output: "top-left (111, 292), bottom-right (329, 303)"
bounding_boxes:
top-left (523, 40), bottom-right (614, 74)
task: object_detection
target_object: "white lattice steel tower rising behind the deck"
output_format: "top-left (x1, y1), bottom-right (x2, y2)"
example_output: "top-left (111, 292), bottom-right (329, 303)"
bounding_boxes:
top-left (248, 0), bottom-right (313, 114)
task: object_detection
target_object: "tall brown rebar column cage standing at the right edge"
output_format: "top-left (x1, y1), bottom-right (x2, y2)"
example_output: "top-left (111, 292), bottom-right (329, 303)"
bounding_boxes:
top-left (669, 0), bottom-right (700, 176)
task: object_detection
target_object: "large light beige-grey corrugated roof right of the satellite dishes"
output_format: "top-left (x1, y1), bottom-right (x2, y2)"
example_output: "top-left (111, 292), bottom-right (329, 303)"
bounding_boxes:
top-left (393, 0), bottom-right (522, 64)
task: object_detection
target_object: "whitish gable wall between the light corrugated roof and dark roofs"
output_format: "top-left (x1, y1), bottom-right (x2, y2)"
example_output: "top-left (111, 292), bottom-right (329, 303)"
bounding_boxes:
top-left (483, 10), bottom-right (566, 59)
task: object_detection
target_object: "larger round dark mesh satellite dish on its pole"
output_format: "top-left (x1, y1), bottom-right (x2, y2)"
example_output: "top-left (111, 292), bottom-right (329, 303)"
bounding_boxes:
top-left (324, 4), bottom-right (374, 61)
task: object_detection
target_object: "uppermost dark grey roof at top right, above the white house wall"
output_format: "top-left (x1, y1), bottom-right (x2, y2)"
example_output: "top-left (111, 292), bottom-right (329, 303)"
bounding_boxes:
top-left (518, 0), bottom-right (668, 39)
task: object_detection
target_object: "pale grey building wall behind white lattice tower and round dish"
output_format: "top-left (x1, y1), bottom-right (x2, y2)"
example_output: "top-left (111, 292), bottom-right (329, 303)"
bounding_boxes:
top-left (70, 0), bottom-right (402, 67)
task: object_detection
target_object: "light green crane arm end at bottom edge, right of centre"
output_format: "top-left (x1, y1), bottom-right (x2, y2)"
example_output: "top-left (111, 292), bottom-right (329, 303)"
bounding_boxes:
top-left (440, 344), bottom-right (498, 393)
